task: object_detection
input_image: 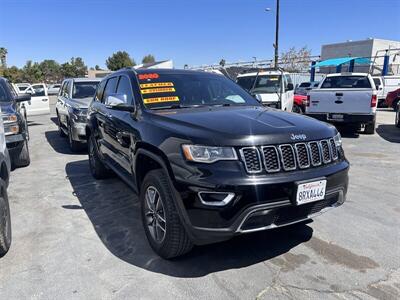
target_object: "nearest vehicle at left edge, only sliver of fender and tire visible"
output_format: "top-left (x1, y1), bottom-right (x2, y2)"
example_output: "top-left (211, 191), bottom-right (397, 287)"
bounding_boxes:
top-left (0, 106), bottom-right (11, 257)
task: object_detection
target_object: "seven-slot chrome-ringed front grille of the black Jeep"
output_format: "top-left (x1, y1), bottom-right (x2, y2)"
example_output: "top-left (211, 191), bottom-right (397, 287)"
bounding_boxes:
top-left (239, 139), bottom-right (339, 174)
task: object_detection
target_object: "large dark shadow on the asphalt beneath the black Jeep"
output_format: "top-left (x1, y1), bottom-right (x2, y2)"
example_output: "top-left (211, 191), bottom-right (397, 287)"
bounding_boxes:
top-left (65, 160), bottom-right (313, 278)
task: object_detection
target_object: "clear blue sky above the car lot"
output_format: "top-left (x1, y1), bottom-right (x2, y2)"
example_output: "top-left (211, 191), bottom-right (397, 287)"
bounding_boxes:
top-left (0, 0), bottom-right (400, 68)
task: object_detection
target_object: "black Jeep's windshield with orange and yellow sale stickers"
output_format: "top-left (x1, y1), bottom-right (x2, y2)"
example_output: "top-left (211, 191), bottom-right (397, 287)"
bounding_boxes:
top-left (138, 73), bottom-right (260, 109)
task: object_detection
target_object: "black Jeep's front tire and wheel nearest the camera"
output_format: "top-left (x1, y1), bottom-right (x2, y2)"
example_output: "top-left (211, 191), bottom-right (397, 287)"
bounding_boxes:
top-left (140, 169), bottom-right (193, 259)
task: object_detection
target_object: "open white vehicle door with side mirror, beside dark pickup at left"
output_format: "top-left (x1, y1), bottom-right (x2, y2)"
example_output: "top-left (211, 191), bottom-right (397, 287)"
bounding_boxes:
top-left (22, 83), bottom-right (50, 116)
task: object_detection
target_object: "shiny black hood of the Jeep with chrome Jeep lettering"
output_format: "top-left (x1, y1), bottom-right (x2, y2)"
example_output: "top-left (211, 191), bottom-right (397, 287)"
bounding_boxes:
top-left (151, 106), bottom-right (336, 145)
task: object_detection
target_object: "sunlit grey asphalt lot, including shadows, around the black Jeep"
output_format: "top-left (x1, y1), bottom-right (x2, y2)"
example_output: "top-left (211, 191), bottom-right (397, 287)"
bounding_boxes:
top-left (0, 97), bottom-right (400, 300)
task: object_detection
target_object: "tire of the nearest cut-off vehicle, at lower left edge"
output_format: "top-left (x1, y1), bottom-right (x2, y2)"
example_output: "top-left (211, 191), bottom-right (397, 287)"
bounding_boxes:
top-left (0, 179), bottom-right (11, 257)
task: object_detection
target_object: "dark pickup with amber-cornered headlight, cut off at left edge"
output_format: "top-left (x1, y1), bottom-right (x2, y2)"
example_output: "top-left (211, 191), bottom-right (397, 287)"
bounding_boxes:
top-left (0, 77), bottom-right (31, 168)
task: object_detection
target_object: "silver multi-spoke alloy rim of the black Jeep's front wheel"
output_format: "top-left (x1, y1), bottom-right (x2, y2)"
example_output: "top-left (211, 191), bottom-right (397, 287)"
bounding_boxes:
top-left (145, 186), bottom-right (167, 243)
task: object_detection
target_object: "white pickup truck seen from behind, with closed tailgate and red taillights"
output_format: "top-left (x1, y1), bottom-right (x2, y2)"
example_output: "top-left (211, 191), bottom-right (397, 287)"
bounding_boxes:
top-left (306, 73), bottom-right (377, 134)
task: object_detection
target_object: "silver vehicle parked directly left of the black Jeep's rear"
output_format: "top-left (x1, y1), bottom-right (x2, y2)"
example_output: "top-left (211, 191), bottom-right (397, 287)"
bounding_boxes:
top-left (56, 78), bottom-right (100, 151)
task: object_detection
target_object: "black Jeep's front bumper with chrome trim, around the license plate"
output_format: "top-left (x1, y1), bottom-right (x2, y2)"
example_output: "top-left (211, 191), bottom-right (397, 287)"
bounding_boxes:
top-left (176, 160), bottom-right (349, 245)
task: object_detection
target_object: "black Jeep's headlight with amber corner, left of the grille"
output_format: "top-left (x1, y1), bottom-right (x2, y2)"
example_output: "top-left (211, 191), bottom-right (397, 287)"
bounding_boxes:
top-left (182, 145), bottom-right (237, 163)
